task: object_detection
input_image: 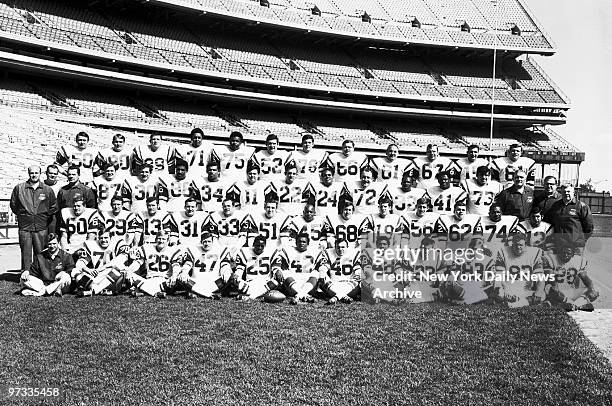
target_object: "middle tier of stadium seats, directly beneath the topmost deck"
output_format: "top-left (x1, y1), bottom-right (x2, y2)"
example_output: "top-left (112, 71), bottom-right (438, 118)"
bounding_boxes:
top-left (0, 0), bottom-right (564, 106)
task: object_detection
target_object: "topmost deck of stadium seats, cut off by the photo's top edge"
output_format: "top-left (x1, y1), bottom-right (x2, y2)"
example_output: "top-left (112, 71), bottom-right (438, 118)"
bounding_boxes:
top-left (150, 0), bottom-right (554, 54)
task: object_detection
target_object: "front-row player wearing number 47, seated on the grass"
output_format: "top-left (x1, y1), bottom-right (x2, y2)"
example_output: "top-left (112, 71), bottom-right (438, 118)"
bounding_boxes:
top-left (175, 232), bottom-right (232, 299)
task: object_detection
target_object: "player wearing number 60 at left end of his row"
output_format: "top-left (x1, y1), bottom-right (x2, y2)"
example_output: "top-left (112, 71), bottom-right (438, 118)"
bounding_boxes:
top-left (59, 195), bottom-right (101, 254)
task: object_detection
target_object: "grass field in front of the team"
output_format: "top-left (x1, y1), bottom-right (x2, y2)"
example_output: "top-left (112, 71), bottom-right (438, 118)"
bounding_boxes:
top-left (0, 281), bottom-right (612, 405)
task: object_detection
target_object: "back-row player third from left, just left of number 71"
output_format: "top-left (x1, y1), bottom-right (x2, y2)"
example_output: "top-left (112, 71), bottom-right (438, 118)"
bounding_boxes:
top-left (130, 134), bottom-right (177, 175)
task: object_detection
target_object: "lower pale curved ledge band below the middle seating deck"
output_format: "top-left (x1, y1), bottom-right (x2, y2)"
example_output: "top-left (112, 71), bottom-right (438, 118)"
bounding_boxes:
top-left (0, 51), bottom-right (565, 126)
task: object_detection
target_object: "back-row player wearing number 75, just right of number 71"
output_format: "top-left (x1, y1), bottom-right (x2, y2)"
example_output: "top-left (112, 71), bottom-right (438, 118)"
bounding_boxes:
top-left (207, 131), bottom-right (255, 182)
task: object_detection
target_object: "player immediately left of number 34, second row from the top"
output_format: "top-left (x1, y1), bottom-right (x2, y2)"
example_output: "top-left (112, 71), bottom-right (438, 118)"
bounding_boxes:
top-left (158, 159), bottom-right (193, 213)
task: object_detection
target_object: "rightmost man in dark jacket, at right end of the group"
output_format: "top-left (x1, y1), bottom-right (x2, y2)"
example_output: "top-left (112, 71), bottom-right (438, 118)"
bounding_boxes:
top-left (544, 185), bottom-right (593, 248)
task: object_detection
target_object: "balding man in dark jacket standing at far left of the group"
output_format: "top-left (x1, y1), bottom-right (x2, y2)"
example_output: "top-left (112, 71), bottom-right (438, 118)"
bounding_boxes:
top-left (10, 166), bottom-right (57, 271)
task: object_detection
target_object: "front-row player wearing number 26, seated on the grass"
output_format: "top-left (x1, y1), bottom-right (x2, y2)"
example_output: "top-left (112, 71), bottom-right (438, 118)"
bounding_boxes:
top-left (125, 229), bottom-right (184, 298)
